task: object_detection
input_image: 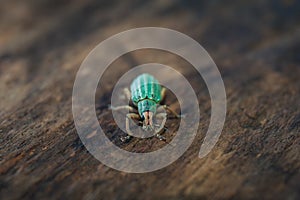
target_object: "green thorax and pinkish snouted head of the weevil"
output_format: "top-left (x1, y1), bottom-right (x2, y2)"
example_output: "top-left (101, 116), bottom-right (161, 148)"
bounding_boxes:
top-left (138, 99), bottom-right (156, 132)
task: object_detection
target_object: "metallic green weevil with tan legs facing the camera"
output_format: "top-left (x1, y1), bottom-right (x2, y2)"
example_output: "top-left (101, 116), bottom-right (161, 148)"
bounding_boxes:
top-left (111, 73), bottom-right (181, 142)
